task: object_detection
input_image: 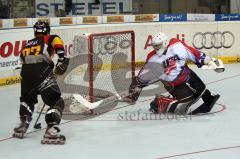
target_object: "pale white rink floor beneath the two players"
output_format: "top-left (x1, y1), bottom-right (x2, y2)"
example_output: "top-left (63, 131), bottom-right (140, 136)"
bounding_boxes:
top-left (0, 64), bottom-right (240, 159)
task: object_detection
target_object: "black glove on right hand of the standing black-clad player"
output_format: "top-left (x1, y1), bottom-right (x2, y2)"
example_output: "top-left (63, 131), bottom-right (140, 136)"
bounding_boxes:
top-left (54, 57), bottom-right (69, 75)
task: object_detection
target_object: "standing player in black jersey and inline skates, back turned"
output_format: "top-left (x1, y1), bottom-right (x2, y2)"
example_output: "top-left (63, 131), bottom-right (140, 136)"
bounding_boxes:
top-left (13, 21), bottom-right (69, 144)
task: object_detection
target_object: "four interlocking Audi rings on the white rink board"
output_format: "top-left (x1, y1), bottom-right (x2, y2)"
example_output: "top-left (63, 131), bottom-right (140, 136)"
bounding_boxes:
top-left (192, 31), bottom-right (235, 49)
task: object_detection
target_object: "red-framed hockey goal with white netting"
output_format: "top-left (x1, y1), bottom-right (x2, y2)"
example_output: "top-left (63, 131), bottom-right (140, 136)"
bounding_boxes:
top-left (37, 31), bottom-right (135, 114)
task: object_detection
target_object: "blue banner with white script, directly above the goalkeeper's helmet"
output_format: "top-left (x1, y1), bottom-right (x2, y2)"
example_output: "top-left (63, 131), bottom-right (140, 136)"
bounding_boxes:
top-left (159, 14), bottom-right (187, 22)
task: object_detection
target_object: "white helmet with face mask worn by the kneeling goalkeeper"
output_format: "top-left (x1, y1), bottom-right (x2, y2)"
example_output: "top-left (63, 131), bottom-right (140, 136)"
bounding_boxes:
top-left (152, 32), bottom-right (169, 56)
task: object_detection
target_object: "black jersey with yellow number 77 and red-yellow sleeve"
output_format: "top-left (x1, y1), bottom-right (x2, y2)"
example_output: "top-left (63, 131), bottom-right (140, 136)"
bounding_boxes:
top-left (20, 35), bottom-right (64, 84)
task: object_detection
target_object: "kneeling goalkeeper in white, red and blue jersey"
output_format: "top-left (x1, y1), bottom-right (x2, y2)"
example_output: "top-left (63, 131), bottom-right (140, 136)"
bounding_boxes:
top-left (126, 32), bottom-right (224, 114)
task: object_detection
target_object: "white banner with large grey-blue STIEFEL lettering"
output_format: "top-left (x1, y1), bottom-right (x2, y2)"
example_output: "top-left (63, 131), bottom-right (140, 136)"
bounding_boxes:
top-left (35, 0), bottom-right (132, 17)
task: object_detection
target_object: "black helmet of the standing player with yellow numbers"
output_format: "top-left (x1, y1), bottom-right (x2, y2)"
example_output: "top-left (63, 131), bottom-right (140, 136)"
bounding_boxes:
top-left (33, 21), bottom-right (50, 36)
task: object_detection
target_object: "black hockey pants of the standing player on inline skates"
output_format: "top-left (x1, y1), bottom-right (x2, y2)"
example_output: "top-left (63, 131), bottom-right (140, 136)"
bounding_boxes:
top-left (19, 73), bottom-right (64, 125)
